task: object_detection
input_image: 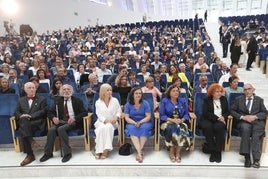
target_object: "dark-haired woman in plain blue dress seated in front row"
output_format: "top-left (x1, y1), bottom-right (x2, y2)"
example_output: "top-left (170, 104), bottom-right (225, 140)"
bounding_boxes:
top-left (125, 87), bottom-right (153, 163)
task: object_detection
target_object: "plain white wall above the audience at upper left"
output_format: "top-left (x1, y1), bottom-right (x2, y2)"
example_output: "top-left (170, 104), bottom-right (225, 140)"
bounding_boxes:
top-left (0, 0), bottom-right (147, 35)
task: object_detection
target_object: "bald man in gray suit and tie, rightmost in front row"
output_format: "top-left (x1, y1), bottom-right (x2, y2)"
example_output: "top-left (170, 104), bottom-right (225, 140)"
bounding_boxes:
top-left (231, 84), bottom-right (267, 168)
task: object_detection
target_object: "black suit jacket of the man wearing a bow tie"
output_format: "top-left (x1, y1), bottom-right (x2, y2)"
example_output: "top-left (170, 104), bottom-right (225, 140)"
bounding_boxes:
top-left (15, 96), bottom-right (47, 134)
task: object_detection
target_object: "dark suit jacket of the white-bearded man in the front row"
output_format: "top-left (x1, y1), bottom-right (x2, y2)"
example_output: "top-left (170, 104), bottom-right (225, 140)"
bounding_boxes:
top-left (48, 96), bottom-right (87, 128)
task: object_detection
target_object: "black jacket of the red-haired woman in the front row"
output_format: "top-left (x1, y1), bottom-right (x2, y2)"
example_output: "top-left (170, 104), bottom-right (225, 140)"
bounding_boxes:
top-left (201, 96), bottom-right (230, 122)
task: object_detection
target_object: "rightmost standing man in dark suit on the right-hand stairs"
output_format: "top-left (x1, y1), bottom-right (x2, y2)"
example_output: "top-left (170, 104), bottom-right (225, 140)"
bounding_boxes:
top-left (246, 32), bottom-right (258, 71)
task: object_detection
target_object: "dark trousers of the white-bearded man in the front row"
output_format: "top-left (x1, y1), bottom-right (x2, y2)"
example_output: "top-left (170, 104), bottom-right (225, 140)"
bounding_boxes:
top-left (45, 120), bottom-right (76, 156)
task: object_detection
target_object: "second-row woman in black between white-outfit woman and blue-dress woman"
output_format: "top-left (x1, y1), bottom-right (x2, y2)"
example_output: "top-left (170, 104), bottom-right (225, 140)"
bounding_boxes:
top-left (113, 75), bottom-right (131, 109)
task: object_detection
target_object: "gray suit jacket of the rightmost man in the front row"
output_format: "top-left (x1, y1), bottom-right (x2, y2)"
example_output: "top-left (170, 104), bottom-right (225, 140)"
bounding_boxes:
top-left (231, 95), bottom-right (267, 122)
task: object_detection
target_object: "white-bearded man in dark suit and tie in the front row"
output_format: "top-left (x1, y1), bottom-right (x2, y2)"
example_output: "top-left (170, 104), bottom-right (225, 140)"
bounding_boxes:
top-left (40, 84), bottom-right (86, 162)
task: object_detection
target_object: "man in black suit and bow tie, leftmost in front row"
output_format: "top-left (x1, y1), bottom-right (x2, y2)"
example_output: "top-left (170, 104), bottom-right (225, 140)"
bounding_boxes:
top-left (15, 82), bottom-right (47, 166)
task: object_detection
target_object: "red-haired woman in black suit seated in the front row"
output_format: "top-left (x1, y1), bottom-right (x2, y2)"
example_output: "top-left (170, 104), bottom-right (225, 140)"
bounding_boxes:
top-left (200, 83), bottom-right (230, 163)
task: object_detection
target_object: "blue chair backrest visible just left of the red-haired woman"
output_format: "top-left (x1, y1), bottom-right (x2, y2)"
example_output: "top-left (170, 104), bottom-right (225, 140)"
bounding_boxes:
top-left (193, 93), bottom-right (207, 136)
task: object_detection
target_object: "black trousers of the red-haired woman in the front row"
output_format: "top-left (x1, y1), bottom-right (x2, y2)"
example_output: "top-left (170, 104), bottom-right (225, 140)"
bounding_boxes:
top-left (201, 120), bottom-right (226, 152)
